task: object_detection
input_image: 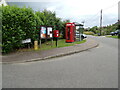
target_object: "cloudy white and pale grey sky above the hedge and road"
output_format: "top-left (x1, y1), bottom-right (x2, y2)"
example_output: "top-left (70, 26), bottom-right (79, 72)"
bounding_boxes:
top-left (6, 0), bottom-right (119, 28)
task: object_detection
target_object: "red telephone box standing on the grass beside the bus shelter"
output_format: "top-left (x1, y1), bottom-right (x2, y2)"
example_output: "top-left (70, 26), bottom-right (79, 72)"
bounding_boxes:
top-left (65, 23), bottom-right (75, 43)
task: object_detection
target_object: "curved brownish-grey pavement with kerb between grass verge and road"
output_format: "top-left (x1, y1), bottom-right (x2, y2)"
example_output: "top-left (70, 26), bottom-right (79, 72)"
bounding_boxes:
top-left (2, 38), bottom-right (99, 63)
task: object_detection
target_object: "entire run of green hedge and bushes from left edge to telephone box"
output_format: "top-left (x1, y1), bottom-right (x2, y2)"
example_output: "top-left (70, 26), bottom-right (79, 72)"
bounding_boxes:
top-left (2, 6), bottom-right (69, 53)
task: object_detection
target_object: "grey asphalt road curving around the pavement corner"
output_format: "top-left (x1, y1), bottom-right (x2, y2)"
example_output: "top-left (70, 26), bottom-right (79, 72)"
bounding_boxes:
top-left (2, 36), bottom-right (118, 88)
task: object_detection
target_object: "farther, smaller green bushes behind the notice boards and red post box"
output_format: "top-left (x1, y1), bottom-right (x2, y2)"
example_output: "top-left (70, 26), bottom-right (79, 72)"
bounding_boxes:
top-left (35, 10), bottom-right (70, 38)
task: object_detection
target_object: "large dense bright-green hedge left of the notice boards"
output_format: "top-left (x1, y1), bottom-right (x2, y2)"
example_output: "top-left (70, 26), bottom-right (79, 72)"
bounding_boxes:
top-left (2, 6), bottom-right (42, 53)
